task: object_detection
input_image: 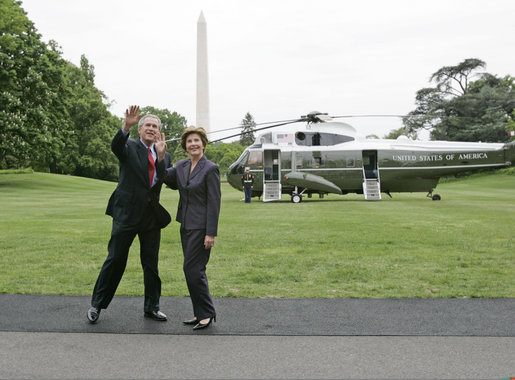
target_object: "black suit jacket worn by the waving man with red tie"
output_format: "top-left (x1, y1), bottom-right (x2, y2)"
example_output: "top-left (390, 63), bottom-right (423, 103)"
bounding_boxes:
top-left (106, 129), bottom-right (171, 227)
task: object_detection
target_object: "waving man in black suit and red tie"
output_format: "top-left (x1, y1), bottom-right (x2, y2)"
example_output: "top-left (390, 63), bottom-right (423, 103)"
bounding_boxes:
top-left (87, 106), bottom-right (171, 323)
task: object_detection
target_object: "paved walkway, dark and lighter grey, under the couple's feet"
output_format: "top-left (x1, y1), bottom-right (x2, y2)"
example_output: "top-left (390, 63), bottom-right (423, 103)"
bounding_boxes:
top-left (0, 294), bottom-right (515, 379)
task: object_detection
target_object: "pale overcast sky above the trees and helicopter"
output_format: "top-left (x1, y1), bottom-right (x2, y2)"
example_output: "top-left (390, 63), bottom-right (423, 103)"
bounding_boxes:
top-left (22, 0), bottom-right (515, 139)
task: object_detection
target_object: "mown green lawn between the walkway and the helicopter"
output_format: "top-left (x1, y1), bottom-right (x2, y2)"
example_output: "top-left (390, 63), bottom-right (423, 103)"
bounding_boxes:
top-left (0, 170), bottom-right (515, 297)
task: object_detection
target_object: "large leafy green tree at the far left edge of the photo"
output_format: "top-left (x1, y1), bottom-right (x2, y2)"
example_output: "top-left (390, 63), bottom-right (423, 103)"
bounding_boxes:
top-left (0, 0), bottom-right (68, 168)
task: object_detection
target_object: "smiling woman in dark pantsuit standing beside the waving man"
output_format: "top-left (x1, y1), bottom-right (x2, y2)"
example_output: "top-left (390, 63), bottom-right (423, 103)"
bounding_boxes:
top-left (164, 127), bottom-right (221, 330)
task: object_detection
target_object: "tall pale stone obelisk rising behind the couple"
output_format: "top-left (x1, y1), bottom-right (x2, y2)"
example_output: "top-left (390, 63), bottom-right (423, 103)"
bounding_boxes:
top-left (196, 12), bottom-right (210, 133)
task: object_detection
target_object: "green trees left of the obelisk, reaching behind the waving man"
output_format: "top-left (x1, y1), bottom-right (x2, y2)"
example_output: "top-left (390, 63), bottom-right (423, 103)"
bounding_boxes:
top-left (0, 0), bottom-right (186, 180)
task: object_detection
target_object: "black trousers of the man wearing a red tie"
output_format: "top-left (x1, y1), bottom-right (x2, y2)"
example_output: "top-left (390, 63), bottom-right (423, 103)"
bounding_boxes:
top-left (91, 204), bottom-right (161, 312)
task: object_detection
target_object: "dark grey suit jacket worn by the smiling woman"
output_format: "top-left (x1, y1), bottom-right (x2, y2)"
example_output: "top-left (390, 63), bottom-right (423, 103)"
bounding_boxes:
top-left (164, 156), bottom-right (221, 236)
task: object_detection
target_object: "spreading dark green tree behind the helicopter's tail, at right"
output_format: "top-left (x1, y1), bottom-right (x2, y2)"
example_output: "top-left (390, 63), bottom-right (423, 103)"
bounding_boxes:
top-left (403, 59), bottom-right (515, 142)
